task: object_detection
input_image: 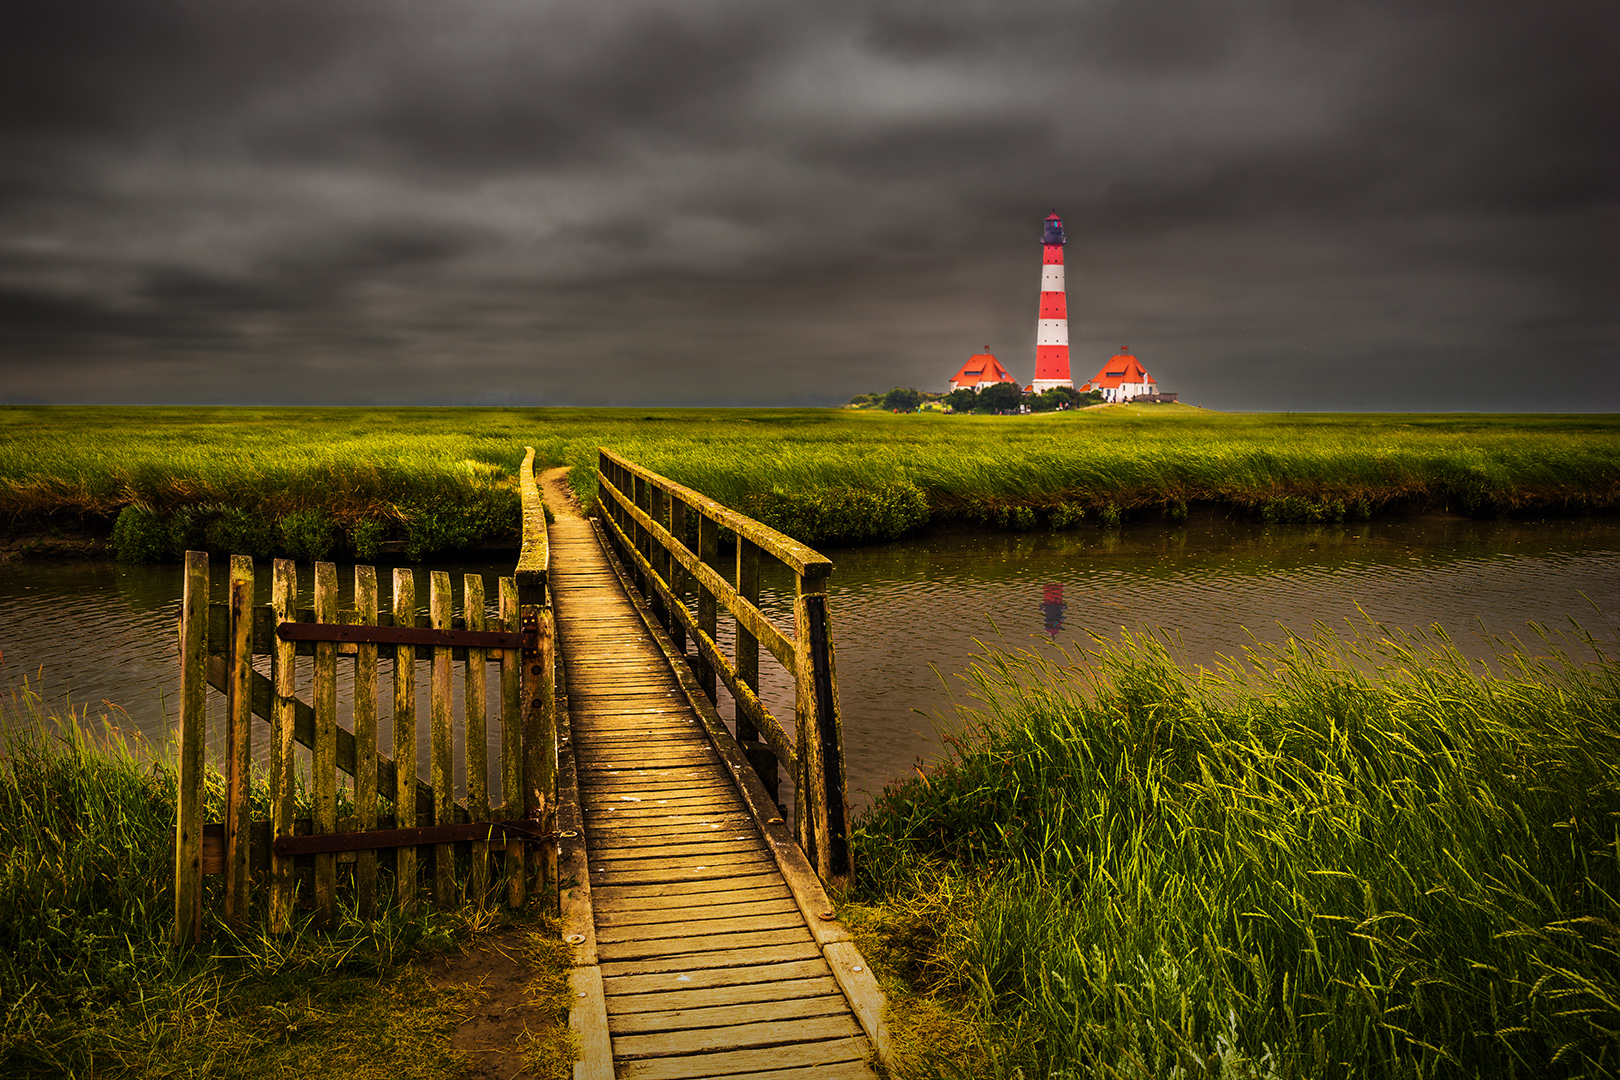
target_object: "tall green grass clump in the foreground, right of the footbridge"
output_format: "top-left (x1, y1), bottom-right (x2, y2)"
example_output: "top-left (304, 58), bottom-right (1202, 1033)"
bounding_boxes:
top-left (849, 633), bottom-right (1620, 1078)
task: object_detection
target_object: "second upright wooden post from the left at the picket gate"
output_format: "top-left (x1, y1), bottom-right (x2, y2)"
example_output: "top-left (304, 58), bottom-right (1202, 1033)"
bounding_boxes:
top-left (225, 555), bottom-right (253, 933)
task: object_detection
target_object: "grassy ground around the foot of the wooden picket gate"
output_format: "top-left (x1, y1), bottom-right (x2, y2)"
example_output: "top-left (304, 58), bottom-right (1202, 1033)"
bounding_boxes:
top-left (0, 696), bottom-right (570, 1080)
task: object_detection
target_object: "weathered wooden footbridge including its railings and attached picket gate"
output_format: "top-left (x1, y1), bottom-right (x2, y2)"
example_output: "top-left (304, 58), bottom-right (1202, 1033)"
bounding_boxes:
top-left (175, 450), bottom-right (889, 1080)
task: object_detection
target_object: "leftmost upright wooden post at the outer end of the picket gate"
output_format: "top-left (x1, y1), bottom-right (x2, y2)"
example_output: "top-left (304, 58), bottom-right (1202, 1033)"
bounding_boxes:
top-left (172, 551), bottom-right (207, 949)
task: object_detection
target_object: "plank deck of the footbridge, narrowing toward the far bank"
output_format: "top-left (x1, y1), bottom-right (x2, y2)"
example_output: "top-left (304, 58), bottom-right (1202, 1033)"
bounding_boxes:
top-left (546, 476), bottom-right (881, 1080)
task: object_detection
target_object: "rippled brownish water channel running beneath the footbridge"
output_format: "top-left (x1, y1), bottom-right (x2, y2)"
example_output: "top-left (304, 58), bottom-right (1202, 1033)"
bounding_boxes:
top-left (0, 518), bottom-right (1620, 806)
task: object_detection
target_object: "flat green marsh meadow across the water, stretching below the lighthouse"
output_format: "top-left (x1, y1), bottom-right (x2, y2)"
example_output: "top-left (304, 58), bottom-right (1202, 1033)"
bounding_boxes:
top-left (0, 406), bottom-right (1620, 559)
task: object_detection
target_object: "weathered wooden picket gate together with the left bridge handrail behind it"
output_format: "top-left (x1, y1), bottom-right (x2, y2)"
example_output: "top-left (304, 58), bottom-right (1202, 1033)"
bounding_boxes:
top-left (173, 449), bottom-right (557, 947)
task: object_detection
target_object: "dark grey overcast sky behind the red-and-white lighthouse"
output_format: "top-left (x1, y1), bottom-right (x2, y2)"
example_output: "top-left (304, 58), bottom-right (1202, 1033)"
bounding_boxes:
top-left (0, 0), bottom-right (1620, 411)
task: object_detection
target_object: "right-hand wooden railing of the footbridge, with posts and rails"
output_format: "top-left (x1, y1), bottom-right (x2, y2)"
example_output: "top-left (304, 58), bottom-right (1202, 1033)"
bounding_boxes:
top-left (596, 447), bottom-right (851, 884)
